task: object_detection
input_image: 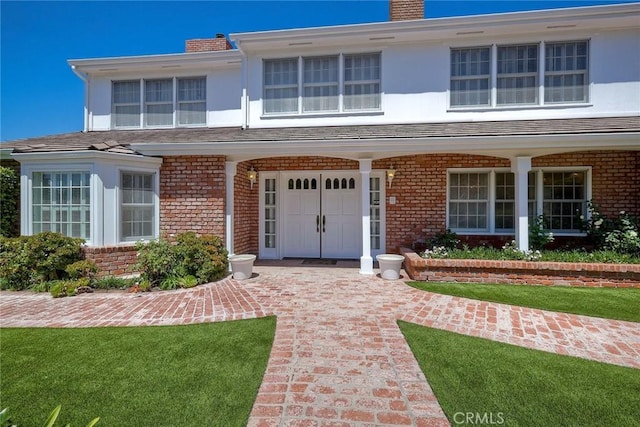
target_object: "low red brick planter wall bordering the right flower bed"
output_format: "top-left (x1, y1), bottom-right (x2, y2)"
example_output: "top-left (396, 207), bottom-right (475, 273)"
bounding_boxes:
top-left (400, 248), bottom-right (640, 288)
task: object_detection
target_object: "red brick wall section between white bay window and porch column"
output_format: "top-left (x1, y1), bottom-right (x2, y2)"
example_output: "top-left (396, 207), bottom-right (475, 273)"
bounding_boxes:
top-left (160, 156), bottom-right (226, 239)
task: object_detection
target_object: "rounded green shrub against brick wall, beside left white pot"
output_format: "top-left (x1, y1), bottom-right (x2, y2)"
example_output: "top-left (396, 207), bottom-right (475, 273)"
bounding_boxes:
top-left (135, 232), bottom-right (229, 289)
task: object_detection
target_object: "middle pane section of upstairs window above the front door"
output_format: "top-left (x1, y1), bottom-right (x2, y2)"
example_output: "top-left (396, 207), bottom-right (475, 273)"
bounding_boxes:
top-left (302, 56), bottom-right (338, 112)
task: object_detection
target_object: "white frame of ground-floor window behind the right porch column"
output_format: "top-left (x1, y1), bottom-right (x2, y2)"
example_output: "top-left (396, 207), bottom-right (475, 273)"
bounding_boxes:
top-left (445, 166), bottom-right (592, 236)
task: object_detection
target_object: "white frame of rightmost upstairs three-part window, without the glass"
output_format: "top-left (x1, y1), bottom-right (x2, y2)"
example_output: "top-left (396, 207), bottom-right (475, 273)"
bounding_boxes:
top-left (447, 38), bottom-right (591, 112)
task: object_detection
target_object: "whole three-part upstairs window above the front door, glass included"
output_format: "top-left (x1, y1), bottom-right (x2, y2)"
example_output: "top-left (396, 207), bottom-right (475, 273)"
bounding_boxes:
top-left (263, 53), bottom-right (381, 114)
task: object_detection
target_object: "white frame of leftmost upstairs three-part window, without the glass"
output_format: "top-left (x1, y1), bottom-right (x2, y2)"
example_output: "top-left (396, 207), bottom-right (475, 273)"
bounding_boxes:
top-left (111, 75), bottom-right (207, 130)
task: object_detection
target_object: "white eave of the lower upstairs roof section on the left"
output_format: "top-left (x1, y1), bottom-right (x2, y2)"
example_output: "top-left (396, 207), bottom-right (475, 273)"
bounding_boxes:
top-left (67, 49), bottom-right (242, 73)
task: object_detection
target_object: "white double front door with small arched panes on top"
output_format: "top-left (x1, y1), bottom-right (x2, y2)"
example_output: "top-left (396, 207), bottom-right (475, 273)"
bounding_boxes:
top-left (283, 172), bottom-right (362, 258)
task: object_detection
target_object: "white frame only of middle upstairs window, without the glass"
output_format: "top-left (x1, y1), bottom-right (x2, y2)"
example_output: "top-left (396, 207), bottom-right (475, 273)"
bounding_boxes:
top-left (262, 51), bottom-right (383, 117)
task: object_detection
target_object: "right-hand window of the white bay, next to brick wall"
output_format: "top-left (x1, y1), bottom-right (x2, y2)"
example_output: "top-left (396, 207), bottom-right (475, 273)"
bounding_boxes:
top-left (120, 172), bottom-right (156, 240)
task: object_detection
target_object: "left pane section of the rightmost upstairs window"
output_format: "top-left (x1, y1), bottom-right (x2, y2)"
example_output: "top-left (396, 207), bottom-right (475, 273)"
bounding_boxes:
top-left (451, 47), bottom-right (491, 107)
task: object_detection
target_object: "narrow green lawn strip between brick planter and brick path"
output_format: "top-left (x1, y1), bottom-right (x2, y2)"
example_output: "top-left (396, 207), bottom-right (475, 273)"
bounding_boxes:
top-left (409, 282), bottom-right (640, 322)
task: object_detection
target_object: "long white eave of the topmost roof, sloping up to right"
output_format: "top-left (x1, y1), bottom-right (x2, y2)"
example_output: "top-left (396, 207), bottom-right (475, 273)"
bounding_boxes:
top-left (229, 3), bottom-right (640, 45)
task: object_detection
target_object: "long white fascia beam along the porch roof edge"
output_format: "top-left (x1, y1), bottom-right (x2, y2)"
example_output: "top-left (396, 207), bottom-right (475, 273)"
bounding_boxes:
top-left (129, 132), bottom-right (640, 161)
